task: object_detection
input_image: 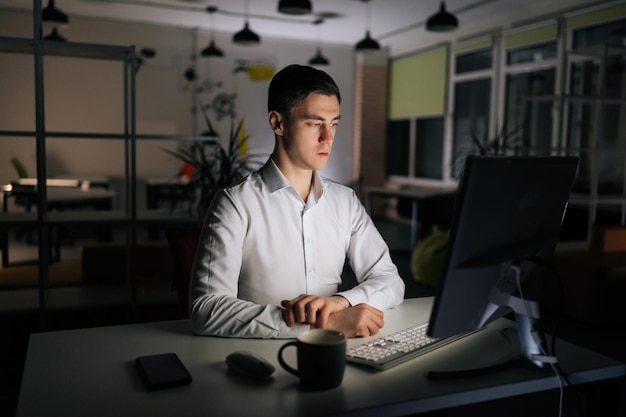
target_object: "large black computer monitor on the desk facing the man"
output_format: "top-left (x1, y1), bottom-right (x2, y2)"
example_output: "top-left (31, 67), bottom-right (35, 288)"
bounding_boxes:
top-left (428, 156), bottom-right (578, 368)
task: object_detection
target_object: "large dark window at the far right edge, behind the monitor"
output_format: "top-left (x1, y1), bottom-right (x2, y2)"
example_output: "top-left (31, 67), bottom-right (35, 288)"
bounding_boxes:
top-left (561, 8), bottom-right (626, 234)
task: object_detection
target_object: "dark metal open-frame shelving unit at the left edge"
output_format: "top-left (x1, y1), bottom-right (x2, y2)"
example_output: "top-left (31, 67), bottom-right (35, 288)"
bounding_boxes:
top-left (0, 0), bottom-right (216, 327)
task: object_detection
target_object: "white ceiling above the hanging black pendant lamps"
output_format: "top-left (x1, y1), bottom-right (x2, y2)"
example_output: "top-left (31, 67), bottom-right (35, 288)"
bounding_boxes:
top-left (0, 0), bottom-right (607, 55)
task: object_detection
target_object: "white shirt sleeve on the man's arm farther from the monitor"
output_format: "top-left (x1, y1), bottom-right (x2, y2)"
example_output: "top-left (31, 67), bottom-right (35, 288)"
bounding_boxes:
top-left (189, 192), bottom-right (309, 338)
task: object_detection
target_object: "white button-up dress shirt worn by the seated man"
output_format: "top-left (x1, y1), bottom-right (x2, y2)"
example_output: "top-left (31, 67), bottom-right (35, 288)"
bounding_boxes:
top-left (189, 159), bottom-right (404, 338)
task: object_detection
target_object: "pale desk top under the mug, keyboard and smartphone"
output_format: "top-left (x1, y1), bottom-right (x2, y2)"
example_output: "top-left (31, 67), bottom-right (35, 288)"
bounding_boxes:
top-left (17, 298), bottom-right (624, 417)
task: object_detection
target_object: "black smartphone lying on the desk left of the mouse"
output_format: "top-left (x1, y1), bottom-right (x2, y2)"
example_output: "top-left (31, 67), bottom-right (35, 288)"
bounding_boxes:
top-left (135, 353), bottom-right (192, 390)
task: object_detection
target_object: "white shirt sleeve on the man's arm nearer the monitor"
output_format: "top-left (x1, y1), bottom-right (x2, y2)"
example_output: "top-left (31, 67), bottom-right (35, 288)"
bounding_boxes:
top-left (339, 188), bottom-right (405, 310)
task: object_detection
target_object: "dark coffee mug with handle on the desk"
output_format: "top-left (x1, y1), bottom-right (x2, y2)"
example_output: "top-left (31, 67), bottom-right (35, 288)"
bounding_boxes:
top-left (278, 329), bottom-right (346, 390)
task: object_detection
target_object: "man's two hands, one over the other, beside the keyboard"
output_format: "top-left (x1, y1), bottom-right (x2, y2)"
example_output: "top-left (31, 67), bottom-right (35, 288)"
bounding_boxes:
top-left (281, 295), bottom-right (385, 337)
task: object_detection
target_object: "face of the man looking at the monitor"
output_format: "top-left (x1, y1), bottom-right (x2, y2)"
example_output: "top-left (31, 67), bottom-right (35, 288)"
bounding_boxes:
top-left (282, 93), bottom-right (340, 170)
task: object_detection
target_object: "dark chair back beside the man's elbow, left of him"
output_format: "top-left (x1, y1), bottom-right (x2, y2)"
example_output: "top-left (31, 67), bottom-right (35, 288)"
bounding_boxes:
top-left (165, 227), bottom-right (200, 318)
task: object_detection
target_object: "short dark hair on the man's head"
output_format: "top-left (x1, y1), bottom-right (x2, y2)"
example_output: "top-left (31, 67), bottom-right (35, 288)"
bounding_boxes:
top-left (267, 64), bottom-right (341, 115)
